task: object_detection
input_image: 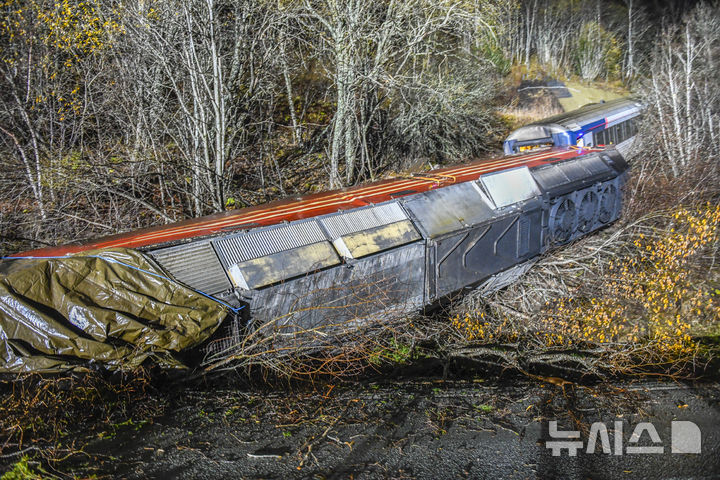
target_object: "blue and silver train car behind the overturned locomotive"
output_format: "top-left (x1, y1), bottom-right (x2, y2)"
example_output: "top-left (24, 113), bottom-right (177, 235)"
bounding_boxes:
top-left (503, 98), bottom-right (642, 155)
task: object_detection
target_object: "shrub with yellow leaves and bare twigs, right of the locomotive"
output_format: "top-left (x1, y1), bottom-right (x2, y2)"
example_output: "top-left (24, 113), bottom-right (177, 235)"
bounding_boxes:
top-left (451, 204), bottom-right (720, 372)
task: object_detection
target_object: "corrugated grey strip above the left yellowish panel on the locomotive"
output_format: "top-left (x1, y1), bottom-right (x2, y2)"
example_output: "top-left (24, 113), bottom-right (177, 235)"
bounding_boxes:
top-left (213, 220), bottom-right (327, 267)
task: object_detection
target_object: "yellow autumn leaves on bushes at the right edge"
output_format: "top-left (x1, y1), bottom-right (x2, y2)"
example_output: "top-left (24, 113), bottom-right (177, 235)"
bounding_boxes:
top-left (451, 204), bottom-right (720, 361)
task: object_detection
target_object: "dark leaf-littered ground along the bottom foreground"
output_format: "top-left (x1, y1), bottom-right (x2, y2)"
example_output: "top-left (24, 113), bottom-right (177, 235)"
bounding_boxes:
top-left (7, 366), bottom-right (720, 479)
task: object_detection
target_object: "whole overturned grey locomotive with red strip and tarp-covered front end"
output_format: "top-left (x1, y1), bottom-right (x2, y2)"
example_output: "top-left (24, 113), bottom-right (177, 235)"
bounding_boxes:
top-left (0, 102), bottom-right (628, 371)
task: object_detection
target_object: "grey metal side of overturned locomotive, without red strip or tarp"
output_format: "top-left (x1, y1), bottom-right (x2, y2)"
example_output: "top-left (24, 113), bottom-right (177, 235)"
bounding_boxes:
top-left (149, 150), bottom-right (627, 350)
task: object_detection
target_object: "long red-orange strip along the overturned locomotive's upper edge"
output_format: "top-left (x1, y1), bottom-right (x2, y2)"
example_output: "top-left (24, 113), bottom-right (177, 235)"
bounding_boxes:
top-left (13, 147), bottom-right (603, 257)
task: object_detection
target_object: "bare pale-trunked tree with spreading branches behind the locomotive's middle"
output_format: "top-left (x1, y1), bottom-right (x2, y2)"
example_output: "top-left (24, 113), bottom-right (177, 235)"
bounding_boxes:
top-left (303, 0), bottom-right (498, 185)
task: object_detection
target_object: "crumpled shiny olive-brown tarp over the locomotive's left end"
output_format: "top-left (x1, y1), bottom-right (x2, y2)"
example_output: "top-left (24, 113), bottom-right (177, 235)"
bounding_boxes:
top-left (0, 249), bottom-right (228, 373)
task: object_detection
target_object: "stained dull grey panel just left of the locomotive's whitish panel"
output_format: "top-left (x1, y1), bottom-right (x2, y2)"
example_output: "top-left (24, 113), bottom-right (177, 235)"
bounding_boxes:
top-left (403, 182), bottom-right (495, 237)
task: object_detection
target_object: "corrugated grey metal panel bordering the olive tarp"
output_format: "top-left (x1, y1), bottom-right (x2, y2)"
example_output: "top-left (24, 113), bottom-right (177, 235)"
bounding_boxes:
top-left (150, 241), bottom-right (232, 295)
